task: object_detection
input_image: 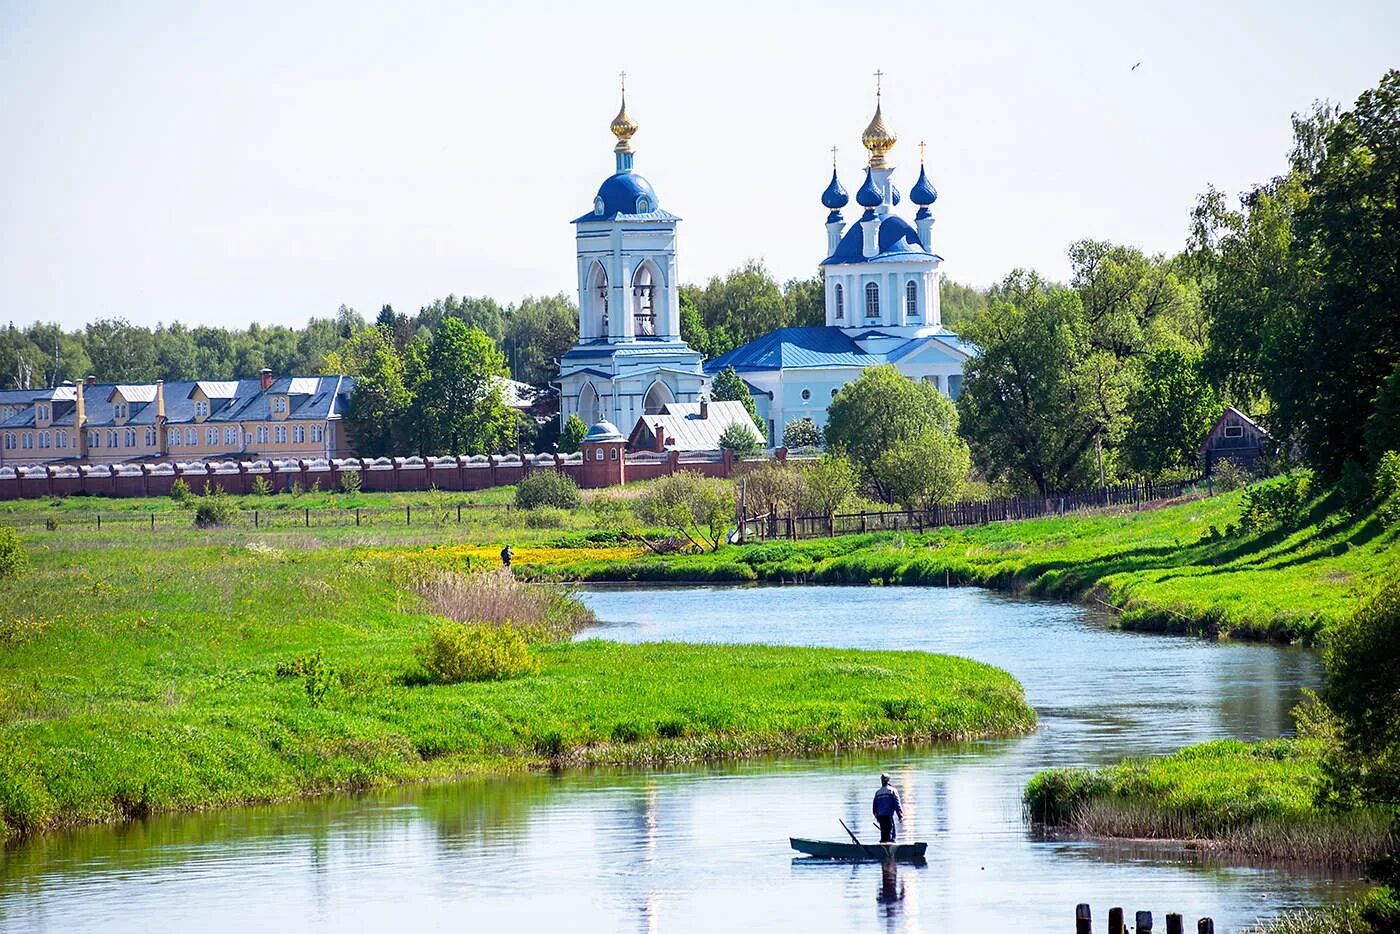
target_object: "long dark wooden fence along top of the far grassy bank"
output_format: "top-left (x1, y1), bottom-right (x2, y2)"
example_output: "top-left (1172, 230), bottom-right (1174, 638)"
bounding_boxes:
top-left (741, 480), bottom-right (1198, 541)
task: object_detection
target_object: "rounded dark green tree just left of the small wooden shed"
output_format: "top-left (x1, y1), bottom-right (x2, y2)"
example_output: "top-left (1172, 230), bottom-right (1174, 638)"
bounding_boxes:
top-left (1123, 347), bottom-right (1221, 476)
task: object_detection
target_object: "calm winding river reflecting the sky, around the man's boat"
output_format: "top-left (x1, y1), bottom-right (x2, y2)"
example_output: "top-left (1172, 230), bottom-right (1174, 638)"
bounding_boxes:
top-left (0, 587), bottom-right (1357, 934)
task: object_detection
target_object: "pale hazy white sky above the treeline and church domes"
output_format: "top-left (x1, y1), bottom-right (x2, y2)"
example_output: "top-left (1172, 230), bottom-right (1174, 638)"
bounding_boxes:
top-left (0, 0), bottom-right (1400, 328)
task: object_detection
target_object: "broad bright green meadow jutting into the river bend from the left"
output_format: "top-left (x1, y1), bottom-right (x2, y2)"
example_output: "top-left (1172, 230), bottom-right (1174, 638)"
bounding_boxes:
top-left (0, 531), bottom-right (1035, 837)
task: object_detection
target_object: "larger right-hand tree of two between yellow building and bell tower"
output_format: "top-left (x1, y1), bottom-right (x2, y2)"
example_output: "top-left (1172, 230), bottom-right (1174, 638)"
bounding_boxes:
top-left (416, 318), bottom-right (515, 454)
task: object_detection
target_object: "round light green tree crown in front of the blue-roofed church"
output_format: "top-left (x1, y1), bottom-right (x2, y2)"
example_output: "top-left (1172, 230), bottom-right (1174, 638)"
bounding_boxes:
top-left (826, 364), bottom-right (969, 503)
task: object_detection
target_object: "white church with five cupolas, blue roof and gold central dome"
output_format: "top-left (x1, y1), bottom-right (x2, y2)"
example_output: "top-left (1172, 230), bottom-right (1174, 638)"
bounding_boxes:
top-left (704, 85), bottom-right (974, 444)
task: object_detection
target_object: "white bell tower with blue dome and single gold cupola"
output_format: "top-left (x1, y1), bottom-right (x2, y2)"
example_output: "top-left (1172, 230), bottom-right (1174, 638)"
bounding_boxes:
top-left (554, 91), bottom-right (704, 433)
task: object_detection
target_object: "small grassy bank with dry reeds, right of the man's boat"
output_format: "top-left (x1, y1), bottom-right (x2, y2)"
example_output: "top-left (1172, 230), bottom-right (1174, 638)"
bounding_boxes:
top-left (1025, 739), bottom-right (1396, 865)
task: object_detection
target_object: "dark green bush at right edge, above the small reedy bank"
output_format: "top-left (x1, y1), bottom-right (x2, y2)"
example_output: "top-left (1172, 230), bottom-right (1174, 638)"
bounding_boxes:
top-left (1322, 577), bottom-right (1400, 807)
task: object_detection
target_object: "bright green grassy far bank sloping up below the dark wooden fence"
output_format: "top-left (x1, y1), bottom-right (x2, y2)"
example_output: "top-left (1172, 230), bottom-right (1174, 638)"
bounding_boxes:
top-left (524, 493), bottom-right (1400, 643)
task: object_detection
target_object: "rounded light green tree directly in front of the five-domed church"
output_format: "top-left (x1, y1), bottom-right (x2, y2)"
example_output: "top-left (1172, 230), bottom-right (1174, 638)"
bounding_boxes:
top-left (826, 364), bottom-right (966, 503)
